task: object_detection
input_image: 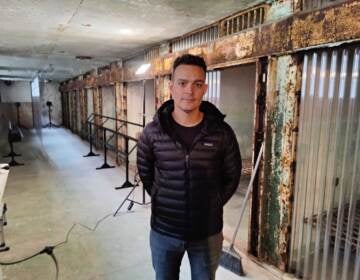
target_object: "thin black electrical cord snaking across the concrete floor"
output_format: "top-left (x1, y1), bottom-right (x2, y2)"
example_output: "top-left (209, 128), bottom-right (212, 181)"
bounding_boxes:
top-left (0, 212), bottom-right (114, 280)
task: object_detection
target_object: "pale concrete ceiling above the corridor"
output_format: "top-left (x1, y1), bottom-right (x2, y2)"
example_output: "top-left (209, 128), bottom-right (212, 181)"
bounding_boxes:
top-left (0, 0), bottom-right (263, 81)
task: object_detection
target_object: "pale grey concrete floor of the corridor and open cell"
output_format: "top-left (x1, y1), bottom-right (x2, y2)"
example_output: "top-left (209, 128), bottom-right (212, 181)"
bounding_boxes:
top-left (0, 129), bottom-right (282, 280)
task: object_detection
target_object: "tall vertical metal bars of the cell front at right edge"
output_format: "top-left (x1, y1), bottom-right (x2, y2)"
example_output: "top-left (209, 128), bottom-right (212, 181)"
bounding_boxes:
top-left (290, 48), bottom-right (360, 280)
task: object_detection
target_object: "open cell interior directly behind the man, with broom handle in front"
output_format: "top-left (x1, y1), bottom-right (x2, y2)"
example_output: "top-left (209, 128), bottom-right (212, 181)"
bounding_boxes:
top-left (204, 63), bottom-right (256, 251)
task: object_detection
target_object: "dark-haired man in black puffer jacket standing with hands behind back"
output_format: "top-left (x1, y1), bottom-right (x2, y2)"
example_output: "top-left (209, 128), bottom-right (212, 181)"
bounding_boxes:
top-left (137, 55), bottom-right (241, 280)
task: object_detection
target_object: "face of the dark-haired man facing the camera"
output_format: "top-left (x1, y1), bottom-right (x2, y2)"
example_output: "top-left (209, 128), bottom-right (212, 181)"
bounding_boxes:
top-left (170, 64), bottom-right (207, 113)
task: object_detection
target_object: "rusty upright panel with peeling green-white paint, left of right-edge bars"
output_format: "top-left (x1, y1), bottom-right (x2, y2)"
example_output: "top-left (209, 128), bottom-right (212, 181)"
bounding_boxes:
top-left (259, 53), bottom-right (301, 270)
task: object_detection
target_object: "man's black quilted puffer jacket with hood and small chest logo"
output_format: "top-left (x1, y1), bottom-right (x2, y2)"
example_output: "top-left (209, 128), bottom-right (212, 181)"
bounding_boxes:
top-left (137, 100), bottom-right (241, 240)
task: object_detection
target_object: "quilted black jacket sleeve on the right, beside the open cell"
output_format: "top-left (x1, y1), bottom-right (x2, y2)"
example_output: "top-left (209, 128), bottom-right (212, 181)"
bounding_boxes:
top-left (222, 126), bottom-right (242, 205)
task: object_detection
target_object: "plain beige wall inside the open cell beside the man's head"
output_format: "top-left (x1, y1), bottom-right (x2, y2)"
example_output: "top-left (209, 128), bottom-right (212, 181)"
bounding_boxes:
top-left (219, 64), bottom-right (256, 159)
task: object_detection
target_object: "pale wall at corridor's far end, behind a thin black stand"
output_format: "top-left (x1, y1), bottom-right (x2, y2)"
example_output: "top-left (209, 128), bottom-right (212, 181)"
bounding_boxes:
top-left (40, 82), bottom-right (62, 125)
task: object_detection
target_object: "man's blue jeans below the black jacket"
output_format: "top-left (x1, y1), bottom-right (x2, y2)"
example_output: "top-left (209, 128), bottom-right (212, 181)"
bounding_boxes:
top-left (150, 230), bottom-right (223, 280)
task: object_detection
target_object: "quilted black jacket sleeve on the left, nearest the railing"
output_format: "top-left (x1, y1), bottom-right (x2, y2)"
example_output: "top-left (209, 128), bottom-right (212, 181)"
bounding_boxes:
top-left (136, 126), bottom-right (154, 194)
